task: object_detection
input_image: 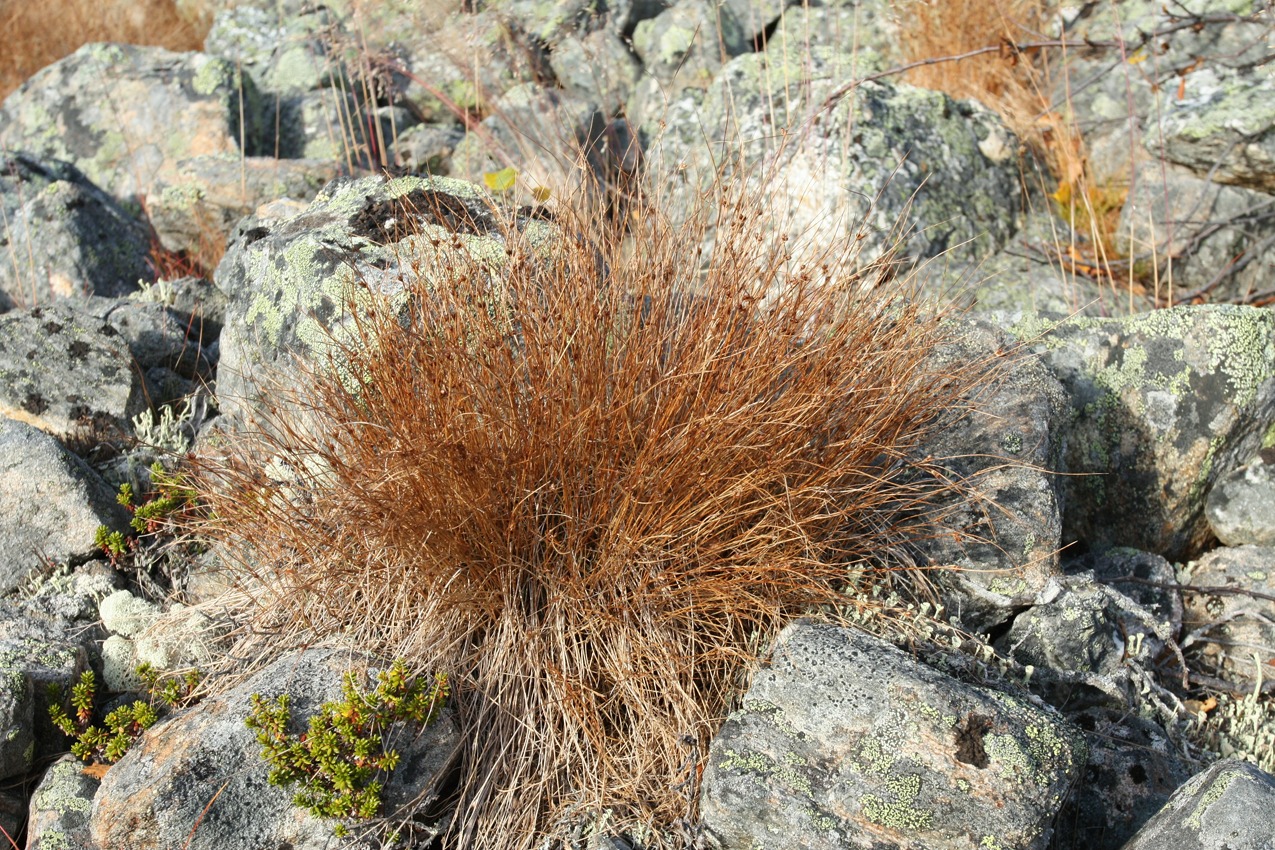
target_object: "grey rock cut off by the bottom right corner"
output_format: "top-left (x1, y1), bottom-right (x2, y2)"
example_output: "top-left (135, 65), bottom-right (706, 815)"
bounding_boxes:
top-left (1123, 761), bottom-right (1275, 850)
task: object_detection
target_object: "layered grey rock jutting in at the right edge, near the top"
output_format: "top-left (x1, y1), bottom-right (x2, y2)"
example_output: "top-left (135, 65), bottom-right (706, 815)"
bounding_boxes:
top-left (1146, 66), bottom-right (1275, 192)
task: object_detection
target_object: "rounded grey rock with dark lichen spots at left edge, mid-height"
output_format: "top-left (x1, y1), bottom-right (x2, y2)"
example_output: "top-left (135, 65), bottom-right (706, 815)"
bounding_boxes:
top-left (0, 302), bottom-right (145, 437)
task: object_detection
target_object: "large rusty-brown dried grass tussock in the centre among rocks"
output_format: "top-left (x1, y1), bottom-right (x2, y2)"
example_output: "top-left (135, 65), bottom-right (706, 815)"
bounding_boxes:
top-left (196, 170), bottom-right (980, 849)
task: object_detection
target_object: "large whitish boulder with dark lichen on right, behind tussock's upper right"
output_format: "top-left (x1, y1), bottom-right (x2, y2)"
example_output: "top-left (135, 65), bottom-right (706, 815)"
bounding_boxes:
top-left (640, 36), bottom-right (1019, 261)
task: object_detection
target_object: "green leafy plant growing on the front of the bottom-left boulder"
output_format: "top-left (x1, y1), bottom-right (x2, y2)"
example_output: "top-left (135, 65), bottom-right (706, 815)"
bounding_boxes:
top-left (245, 660), bottom-right (448, 836)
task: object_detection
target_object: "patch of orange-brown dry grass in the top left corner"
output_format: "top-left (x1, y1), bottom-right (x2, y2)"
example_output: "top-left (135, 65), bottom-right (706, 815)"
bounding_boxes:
top-left (0, 0), bottom-right (213, 98)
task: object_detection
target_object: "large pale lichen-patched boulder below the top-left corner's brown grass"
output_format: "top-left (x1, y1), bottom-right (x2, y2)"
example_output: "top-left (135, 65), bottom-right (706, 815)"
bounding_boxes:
top-left (0, 45), bottom-right (261, 201)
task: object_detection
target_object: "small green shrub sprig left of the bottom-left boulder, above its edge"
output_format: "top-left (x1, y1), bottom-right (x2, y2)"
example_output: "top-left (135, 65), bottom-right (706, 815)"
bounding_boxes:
top-left (48, 664), bottom-right (200, 765)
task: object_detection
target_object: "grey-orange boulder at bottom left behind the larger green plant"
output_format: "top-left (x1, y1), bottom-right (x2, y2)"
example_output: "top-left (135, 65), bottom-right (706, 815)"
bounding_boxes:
top-left (91, 650), bottom-right (459, 850)
